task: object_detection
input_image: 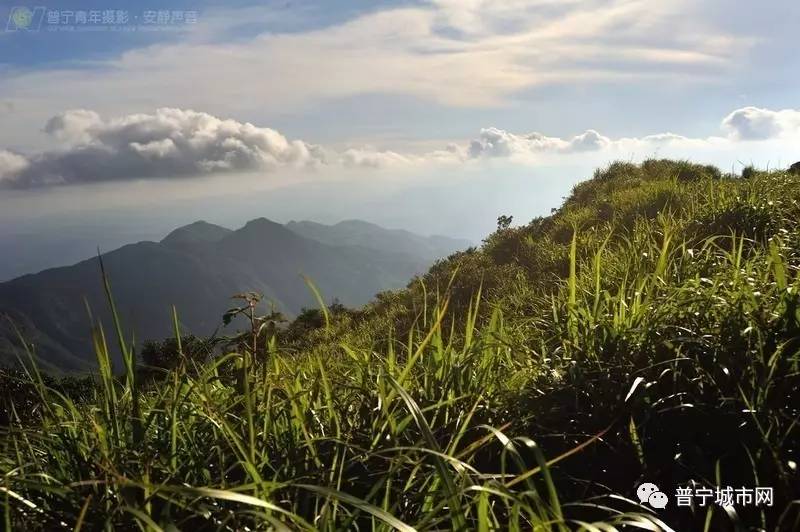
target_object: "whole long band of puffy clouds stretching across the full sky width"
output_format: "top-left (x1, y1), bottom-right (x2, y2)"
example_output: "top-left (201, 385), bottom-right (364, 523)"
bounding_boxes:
top-left (0, 103), bottom-right (800, 188)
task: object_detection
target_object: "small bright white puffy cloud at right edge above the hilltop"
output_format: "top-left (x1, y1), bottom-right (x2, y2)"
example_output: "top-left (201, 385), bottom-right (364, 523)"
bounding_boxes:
top-left (722, 107), bottom-right (800, 140)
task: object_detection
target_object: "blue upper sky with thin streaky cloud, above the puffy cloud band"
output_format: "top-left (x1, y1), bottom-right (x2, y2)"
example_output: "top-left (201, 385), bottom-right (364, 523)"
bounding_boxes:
top-left (0, 0), bottom-right (800, 150)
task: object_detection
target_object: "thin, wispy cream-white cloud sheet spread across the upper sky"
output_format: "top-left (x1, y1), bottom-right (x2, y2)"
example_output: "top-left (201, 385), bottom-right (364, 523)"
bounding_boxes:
top-left (0, 0), bottom-right (752, 150)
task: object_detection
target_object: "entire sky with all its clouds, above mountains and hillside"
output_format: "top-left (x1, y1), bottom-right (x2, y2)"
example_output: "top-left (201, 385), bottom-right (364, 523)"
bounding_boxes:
top-left (0, 0), bottom-right (800, 279)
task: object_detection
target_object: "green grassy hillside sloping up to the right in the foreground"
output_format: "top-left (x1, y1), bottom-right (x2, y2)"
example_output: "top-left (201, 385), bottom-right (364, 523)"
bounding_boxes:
top-left (0, 161), bottom-right (800, 531)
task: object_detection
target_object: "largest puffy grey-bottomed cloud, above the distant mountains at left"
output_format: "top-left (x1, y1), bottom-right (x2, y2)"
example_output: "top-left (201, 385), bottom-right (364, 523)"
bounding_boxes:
top-left (0, 108), bottom-right (338, 187)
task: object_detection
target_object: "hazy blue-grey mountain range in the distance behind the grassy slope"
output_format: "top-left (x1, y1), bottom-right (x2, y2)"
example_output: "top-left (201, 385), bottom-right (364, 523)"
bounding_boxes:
top-left (0, 218), bottom-right (469, 370)
